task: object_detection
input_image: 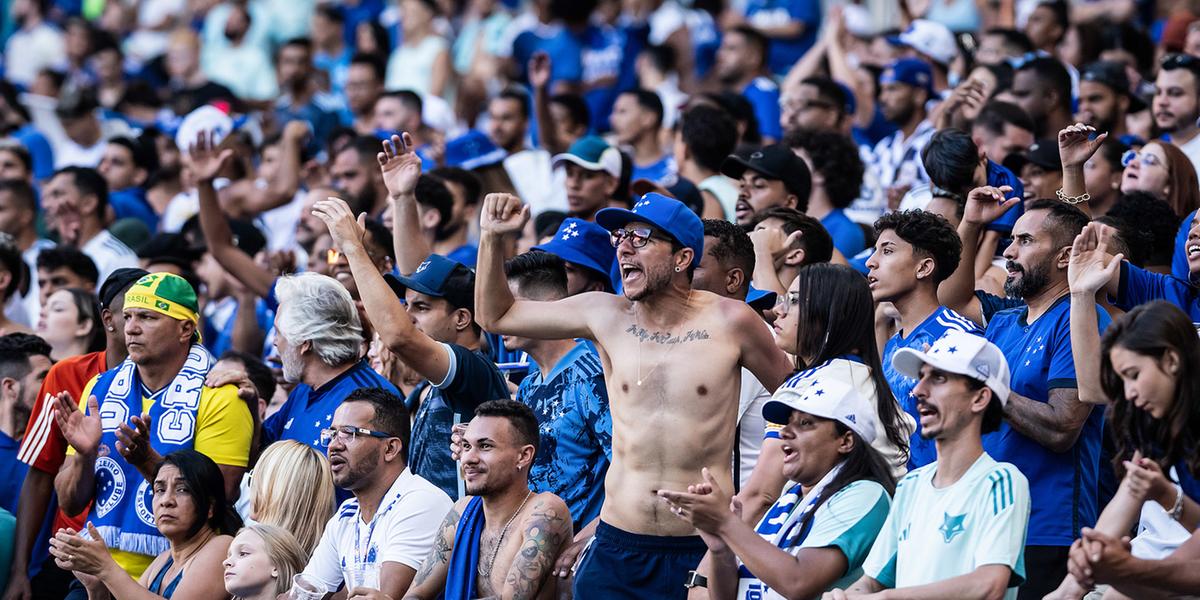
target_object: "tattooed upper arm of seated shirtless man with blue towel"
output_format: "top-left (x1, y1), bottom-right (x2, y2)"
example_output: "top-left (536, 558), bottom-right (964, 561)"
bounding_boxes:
top-left (504, 500), bottom-right (571, 600)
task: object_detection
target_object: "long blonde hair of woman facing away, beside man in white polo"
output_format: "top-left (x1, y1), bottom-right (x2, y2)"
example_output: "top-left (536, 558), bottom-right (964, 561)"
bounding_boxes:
top-left (250, 439), bottom-right (336, 554)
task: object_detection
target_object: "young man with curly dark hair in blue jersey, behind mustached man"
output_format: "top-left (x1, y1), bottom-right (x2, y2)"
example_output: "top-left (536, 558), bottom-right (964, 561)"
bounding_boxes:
top-left (866, 210), bottom-right (983, 469)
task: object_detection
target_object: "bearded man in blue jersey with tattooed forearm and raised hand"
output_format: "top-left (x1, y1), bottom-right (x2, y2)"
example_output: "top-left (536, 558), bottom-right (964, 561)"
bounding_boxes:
top-left (938, 187), bottom-right (1111, 599)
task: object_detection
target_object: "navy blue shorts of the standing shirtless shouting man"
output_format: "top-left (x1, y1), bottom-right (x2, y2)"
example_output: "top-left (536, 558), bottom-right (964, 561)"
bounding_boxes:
top-left (574, 521), bottom-right (708, 600)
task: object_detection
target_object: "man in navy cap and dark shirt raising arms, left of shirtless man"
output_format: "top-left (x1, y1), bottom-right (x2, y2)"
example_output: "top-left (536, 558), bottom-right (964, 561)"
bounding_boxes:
top-left (313, 141), bottom-right (509, 498)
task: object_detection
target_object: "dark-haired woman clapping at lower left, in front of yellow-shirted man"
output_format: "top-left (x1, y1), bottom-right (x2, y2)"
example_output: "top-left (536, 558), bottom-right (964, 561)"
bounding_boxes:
top-left (50, 450), bottom-right (241, 600)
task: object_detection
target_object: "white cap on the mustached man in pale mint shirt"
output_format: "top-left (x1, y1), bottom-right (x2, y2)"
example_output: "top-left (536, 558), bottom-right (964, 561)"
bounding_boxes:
top-left (892, 329), bottom-right (1009, 406)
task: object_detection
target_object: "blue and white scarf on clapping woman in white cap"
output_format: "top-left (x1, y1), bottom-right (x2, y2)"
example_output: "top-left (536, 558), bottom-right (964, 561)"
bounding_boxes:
top-left (737, 462), bottom-right (846, 600)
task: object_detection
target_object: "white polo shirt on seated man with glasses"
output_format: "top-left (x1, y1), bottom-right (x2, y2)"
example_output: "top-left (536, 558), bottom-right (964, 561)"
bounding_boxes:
top-left (304, 468), bottom-right (454, 592)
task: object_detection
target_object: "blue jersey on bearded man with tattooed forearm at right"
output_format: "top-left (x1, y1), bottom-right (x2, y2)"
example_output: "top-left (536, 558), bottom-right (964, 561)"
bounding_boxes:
top-left (983, 295), bottom-right (1111, 546)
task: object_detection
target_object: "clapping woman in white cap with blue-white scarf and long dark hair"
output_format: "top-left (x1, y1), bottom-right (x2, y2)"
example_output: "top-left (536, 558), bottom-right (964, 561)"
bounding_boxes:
top-left (659, 380), bottom-right (895, 600)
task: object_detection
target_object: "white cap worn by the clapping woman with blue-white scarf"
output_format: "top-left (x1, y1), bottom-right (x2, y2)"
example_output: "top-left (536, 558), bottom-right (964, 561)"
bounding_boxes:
top-left (762, 378), bottom-right (876, 444)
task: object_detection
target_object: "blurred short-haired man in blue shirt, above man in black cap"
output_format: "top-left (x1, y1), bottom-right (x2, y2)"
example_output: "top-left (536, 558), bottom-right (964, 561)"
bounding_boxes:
top-left (713, 25), bottom-right (784, 143)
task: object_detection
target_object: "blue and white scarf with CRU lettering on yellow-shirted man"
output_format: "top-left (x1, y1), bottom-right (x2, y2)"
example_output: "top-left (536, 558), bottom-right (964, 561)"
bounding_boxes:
top-left (92, 344), bottom-right (216, 556)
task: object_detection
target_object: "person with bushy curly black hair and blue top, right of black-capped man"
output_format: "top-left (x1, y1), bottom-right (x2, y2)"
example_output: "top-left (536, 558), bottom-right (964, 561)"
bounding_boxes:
top-left (787, 130), bottom-right (868, 258)
